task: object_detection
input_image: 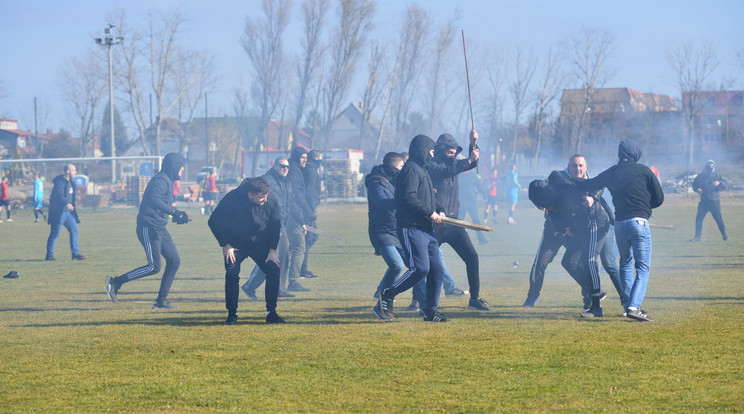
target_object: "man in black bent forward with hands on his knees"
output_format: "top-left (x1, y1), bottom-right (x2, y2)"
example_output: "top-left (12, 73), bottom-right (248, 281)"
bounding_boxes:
top-left (208, 177), bottom-right (284, 325)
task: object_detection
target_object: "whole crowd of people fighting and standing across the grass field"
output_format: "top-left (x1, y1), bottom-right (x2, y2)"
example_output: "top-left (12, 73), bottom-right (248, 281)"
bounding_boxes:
top-left (8, 133), bottom-right (728, 325)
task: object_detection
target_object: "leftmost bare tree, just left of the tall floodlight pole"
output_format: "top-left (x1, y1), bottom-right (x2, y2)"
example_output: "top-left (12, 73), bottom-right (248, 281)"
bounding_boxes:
top-left (60, 51), bottom-right (107, 157)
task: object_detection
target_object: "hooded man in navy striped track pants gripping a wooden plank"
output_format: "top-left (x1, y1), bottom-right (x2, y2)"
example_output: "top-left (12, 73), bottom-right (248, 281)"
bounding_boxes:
top-left (378, 135), bottom-right (447, 322)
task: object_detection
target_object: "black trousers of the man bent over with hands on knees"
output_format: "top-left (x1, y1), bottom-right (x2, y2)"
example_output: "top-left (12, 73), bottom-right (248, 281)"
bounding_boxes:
top-left (224, 249), bottom-right (279, 315)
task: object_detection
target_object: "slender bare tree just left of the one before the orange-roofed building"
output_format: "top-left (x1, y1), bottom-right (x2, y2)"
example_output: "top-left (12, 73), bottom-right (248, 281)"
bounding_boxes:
top-left (534, 48), bottom-right (565, 160)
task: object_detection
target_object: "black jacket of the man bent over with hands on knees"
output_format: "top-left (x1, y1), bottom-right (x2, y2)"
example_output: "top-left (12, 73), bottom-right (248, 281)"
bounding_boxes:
top-left (207, 181), bottom-right (282, 257)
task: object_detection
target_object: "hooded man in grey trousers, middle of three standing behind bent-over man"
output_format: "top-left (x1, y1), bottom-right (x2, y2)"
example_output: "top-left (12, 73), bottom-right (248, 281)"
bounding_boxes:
top-left (287, 147), bottom-right (317, 292)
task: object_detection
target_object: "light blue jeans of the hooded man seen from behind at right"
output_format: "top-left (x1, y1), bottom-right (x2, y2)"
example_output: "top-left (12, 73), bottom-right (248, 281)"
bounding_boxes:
top-left (615, 218), bottom-right (651, 309)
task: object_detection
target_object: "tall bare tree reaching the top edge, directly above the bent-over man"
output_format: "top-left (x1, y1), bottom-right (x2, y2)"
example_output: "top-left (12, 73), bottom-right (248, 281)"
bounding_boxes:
top-left (241, 0), bottom-right (292, 175)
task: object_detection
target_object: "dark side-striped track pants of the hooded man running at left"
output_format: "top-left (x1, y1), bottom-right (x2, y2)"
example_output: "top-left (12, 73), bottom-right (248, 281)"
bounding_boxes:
top-left (114, 226), bottom-right (181, 302)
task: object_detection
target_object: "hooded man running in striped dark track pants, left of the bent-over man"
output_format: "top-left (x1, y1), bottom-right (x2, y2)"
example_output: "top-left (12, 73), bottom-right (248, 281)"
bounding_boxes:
top-left (106, 152), bottom-right (189, 309)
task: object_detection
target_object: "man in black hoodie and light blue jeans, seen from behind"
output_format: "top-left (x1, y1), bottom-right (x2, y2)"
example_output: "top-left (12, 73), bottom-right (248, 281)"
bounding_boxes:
top-left (578, 140), bottom-right (664, 322)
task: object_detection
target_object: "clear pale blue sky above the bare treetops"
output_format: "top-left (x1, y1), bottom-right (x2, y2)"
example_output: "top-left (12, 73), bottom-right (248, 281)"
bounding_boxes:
top-left (0, 0), bottom-right (744, 131)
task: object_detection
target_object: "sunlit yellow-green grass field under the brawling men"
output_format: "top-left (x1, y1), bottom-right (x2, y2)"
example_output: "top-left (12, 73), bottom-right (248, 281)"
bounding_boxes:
top-left (0, 196), bottom-right (744, 413)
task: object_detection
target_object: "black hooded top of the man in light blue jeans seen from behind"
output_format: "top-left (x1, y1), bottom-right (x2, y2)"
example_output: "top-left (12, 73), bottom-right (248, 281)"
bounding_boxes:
top-left (578, 140), bottom-right (664, 221)
